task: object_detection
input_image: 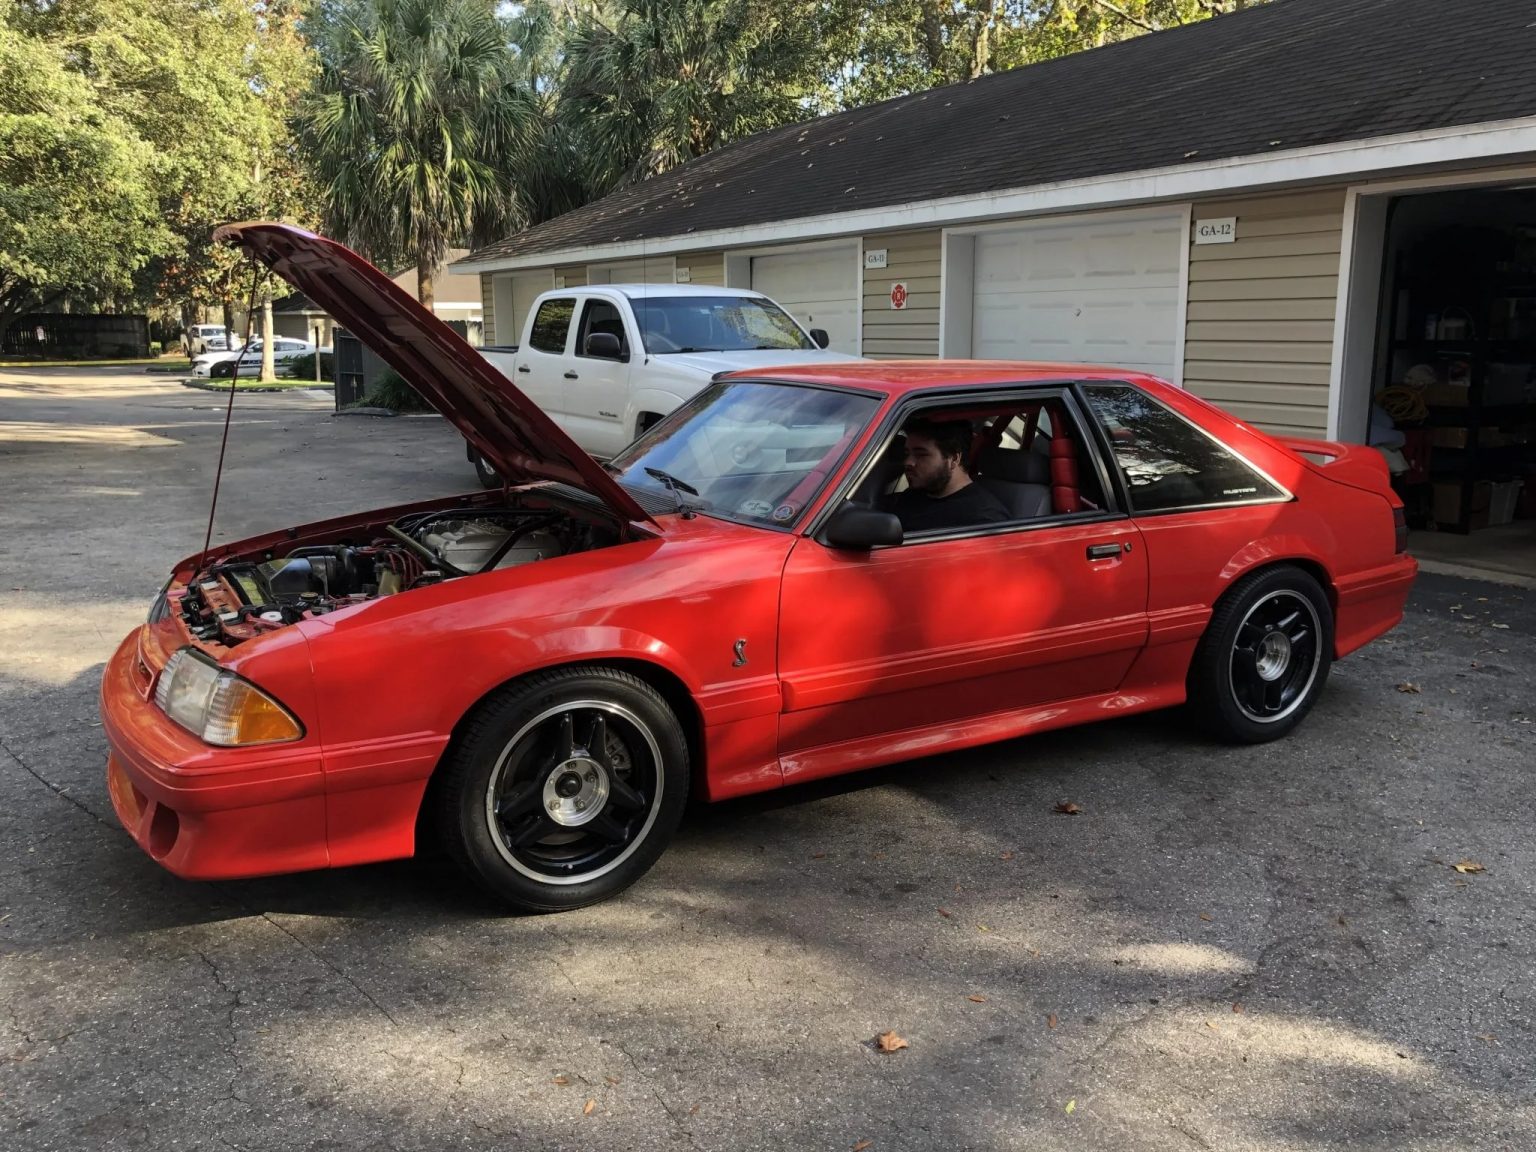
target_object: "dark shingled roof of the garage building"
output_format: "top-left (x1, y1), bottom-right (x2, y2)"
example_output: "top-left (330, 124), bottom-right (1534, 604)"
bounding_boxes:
top-left (467, 0), bottom-right (1536, 261)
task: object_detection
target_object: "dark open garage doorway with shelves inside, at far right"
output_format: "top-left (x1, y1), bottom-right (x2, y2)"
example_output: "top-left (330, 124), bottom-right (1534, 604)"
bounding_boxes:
top-left (1338, 180), bottom-right (1536, 579)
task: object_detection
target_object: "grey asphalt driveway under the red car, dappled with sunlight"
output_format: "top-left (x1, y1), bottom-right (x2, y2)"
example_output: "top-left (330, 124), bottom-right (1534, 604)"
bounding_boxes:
top-left (0, 369), bottom-right (1536, 1152)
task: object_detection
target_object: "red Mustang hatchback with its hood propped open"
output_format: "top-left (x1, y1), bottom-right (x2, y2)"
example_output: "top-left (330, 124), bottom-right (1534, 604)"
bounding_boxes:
top-left (101, 224), bottom-right (1416, 911)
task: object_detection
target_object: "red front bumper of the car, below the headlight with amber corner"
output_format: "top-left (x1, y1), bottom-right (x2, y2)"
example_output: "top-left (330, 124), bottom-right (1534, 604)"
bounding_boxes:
top-left (101, 630), bottom-right (330, 880)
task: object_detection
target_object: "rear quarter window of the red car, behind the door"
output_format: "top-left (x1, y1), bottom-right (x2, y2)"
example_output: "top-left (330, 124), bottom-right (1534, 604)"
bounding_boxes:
top-left (1084, 384), bottom-right (1286, 511)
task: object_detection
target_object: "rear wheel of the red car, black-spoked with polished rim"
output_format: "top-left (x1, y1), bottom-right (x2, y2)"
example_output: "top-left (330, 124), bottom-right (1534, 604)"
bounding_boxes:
top-left (1189, 564), bottom-right (1333, 743)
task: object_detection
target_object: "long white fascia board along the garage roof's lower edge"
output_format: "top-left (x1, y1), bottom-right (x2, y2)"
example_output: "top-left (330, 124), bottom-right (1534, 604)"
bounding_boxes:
top-left (450, 117), bottom-right (1536, 273)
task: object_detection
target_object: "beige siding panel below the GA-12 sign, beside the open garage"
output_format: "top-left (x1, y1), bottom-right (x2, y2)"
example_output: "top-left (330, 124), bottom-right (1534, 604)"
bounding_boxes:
top-left (1184, 187), bottom-right (1344, 436)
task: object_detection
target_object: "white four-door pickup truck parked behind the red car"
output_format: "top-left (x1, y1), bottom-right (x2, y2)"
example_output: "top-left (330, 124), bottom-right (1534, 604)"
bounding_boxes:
top-left (468, 284), bottom-right (856, 487)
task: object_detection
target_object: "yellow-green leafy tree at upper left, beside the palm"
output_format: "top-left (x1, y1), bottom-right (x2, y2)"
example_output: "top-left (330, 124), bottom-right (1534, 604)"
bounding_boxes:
top-left (0, 0), bottom-right (312, 342)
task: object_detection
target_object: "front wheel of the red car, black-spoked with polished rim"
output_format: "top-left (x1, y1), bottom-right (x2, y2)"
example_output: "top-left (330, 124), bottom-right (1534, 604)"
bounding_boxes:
top-left (433, 667), bottom-right (690, 912)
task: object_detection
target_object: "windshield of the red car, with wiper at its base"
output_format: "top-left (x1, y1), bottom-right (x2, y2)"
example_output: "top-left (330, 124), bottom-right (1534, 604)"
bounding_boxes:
top-left (608, 384), bottom-right (880, 528)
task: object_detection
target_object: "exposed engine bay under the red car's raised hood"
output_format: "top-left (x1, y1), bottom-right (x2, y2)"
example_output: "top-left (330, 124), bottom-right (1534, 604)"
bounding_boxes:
top-left (167, 505), bottom-right (621, 645)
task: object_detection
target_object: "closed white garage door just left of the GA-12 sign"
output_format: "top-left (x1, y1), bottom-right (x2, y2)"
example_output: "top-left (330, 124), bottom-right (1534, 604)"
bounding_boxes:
top-left (971, 217), bottom-right (1184, 379)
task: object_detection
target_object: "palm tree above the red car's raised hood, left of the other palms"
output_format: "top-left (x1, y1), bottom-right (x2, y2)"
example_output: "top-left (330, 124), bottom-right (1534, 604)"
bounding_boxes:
top-left (298, 0), bottom-right (539, 307)
